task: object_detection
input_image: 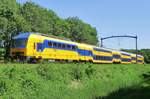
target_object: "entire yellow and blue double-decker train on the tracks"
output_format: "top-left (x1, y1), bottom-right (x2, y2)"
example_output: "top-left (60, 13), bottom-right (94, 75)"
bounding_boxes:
top-left (10, 32), bottom-right (144, 64)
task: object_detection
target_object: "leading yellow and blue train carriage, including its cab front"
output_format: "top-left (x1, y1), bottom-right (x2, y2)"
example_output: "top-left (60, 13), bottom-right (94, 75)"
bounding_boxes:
top-left (11, 33), bottom-right (79, 60)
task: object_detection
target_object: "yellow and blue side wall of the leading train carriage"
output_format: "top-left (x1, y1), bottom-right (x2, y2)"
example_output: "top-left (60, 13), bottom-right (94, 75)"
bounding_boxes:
top-left (27, 35), bottom-right (79, 60)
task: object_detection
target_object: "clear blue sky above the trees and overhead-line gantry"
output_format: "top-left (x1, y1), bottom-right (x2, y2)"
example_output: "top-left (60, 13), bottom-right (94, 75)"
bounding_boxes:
top-left (17, 0), bottom-right (150, 49)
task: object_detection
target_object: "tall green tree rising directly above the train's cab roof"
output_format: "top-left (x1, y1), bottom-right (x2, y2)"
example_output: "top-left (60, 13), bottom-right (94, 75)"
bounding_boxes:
top-left (20, 2), bottom-right (59, 34)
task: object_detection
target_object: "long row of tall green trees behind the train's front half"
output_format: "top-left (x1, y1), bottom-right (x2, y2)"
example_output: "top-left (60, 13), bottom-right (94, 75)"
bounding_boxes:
top-left (0, 0), bottom-right (97, 59)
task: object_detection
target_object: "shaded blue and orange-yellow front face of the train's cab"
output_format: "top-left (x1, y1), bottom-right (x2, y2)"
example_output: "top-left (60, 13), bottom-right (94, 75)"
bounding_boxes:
top-left (10, 33), bottom-right (30, 60)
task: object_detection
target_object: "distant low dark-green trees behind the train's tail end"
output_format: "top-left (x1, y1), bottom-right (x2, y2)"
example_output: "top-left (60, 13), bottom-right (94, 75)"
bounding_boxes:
top-left (122, 49), bottom-right (150, 63)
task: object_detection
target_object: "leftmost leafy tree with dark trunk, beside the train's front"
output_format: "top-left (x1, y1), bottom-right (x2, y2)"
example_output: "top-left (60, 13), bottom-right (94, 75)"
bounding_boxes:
top-left (0, 0), bottom-right (30, 59)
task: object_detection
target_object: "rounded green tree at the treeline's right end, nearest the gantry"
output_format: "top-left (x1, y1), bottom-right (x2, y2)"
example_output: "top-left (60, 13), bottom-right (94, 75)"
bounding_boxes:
top-left (66, 17), bottom-right (97, 44)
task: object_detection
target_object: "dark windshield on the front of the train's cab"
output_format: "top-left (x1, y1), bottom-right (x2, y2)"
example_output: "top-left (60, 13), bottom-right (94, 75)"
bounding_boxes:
top-left (12, 39), bottom-right (27, 48)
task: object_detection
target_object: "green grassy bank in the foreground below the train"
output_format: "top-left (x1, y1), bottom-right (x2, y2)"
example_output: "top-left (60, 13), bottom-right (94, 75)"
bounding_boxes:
top-left (0, 63), bottom-right (150, 99)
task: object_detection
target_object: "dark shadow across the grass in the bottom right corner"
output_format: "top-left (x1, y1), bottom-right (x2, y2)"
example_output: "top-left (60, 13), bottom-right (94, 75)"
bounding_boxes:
top-left (96, 72), bottom-right (150, 99)
